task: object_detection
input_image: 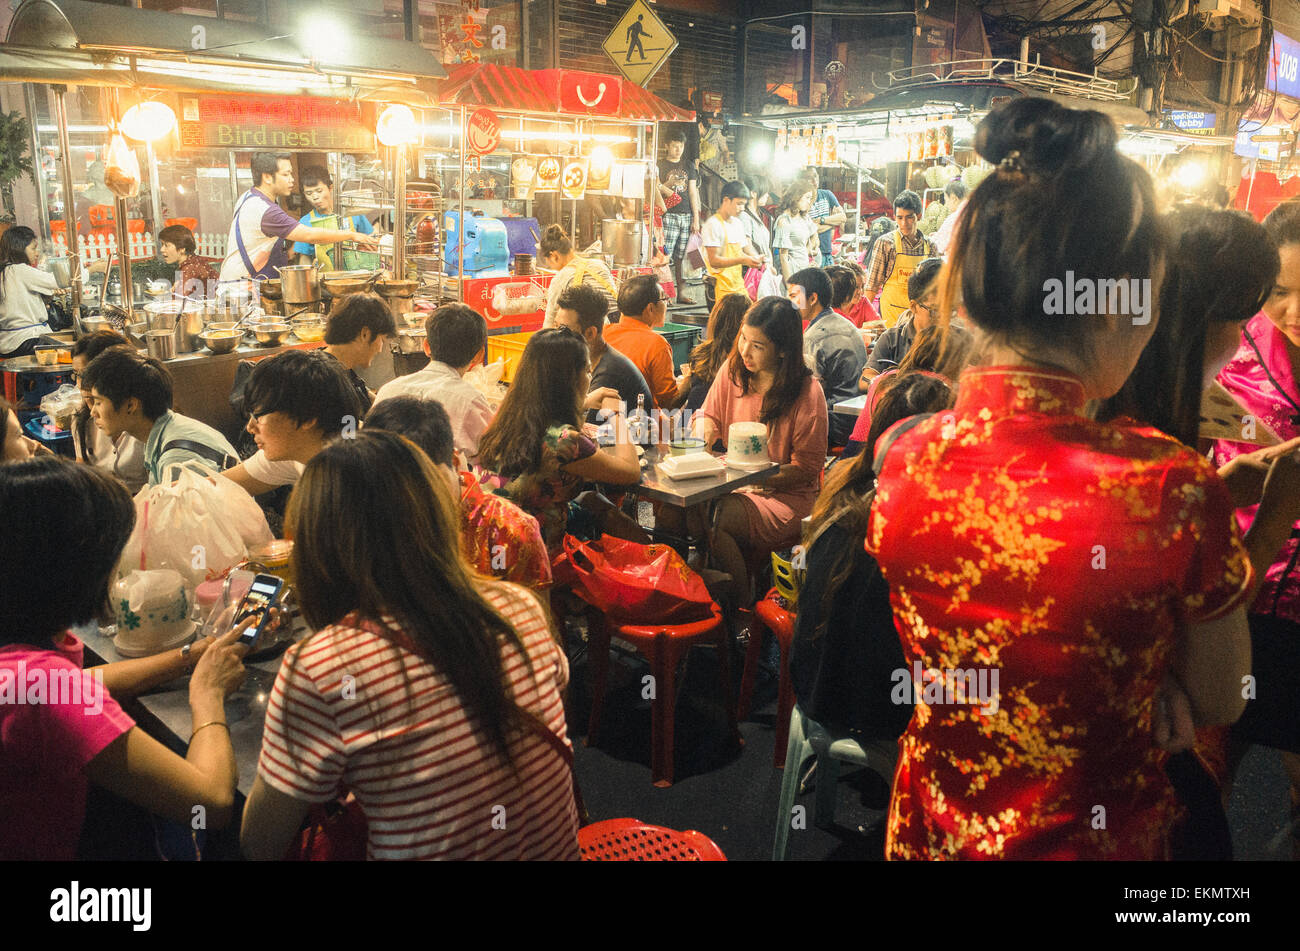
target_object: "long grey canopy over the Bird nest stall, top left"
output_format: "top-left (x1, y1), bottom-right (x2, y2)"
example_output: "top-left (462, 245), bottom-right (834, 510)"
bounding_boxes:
top-left (0, 0), bottom-right (446, 105)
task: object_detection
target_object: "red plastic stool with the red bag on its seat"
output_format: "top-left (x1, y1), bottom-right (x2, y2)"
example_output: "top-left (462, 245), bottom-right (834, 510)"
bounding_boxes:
top-left (579, 594), bottom-right (745, 787)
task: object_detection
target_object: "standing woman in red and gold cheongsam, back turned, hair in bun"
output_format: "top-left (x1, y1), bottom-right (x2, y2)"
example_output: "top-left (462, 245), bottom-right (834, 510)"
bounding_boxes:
top-left (867, 97), bottom-right (1251, 859)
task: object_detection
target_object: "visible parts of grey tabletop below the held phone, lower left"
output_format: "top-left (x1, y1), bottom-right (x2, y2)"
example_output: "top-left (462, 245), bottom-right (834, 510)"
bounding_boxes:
top-left (73, 624), bottom-right (283, 796)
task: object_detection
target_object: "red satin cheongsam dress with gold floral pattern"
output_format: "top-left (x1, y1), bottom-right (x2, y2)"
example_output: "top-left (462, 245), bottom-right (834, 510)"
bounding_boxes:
top-left (867, 366), bottom-right (1251, 859)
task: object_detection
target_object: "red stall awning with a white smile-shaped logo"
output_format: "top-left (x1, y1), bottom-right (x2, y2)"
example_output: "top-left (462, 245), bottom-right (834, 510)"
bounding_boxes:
top-left (438, 62), bottom-right (696, 122)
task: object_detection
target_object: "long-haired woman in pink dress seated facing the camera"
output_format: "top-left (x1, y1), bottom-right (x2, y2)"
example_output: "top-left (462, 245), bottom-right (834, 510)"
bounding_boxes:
top-left (694, 298), bottom-right (827, 604)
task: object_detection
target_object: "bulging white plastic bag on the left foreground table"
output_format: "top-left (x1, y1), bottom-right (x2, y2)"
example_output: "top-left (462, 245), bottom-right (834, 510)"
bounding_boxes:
top-left (118, 465), bottom-right (272, 587)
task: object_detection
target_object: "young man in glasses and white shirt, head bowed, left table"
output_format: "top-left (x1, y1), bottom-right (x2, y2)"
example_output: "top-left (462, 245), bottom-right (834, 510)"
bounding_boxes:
top-left (222, 349), bottom-right (361, 495)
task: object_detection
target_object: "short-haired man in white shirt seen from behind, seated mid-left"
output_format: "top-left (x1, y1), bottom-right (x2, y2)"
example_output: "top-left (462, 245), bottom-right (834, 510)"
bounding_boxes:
top-left (374, 304), bottom-right (494, 460)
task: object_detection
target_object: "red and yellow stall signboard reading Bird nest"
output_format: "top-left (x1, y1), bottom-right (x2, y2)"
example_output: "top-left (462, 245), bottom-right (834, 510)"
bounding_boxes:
top-left (179, 96), bottom-right (374, 152)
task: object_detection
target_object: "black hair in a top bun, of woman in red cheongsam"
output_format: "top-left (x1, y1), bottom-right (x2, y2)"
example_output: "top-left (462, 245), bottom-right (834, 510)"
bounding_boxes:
top-left (940, 96), bottom-right (1165, 360)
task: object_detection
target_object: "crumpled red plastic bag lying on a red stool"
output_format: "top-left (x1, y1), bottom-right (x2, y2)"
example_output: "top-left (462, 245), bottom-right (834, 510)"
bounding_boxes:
top-left (555, 535), bottom-right (714, 624)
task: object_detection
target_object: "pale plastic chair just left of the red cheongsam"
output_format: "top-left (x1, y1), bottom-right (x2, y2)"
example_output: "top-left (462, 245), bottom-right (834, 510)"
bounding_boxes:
top-left (772, 704), bottom-right (898, 861)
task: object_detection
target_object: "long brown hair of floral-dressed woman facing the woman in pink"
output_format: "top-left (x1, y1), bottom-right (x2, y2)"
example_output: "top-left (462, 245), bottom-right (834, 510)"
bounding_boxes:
top-left (478, 328), bottom-right (592, 479)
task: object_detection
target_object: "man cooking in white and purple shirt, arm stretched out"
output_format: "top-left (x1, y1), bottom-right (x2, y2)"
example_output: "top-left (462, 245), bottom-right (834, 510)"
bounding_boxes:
top-left (220, 152), bottom-right (378, 286)
